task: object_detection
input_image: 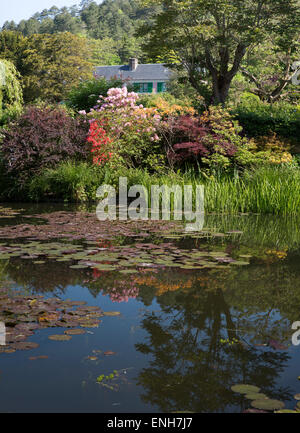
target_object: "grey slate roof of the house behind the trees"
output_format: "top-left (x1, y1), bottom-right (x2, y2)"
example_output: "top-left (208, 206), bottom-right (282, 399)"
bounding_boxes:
top-left (95, 63), bottom-right (171, 81)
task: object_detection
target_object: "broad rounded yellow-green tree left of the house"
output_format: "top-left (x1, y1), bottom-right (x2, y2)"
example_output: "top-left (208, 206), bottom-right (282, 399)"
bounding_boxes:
top-left (21, 32), bottom-right (92, 102)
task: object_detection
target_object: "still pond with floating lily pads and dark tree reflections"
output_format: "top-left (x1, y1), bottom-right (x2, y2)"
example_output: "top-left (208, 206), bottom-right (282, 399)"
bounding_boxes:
top-left (0, 204), bottom-right (300, 413)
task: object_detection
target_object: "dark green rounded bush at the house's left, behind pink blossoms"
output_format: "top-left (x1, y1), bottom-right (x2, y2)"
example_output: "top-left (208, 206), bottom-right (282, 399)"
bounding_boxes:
top-left (67, 78), bottom-right (128, 111)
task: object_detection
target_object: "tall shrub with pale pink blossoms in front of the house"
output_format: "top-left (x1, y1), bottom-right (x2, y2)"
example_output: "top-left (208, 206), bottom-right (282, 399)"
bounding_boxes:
top-left (88, 87), bottom-right (165, 170)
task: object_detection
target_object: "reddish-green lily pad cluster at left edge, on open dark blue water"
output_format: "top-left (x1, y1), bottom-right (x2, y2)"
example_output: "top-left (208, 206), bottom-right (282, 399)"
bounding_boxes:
top-left (0, 289), bottom-right (116, 353)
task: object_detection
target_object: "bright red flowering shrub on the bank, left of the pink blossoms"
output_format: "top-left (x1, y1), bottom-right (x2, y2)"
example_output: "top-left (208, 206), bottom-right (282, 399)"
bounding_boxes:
top-left (87, 120), bottom-right (112, 165)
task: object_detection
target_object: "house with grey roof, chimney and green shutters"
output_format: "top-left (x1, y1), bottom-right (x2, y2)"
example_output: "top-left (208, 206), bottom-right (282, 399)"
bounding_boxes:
top-left (94, 58), bottom-right (171, 93)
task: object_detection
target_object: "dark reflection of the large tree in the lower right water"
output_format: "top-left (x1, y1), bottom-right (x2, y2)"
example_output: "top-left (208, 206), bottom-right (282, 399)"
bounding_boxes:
top-left (136, 289), bottom-right (290, 412)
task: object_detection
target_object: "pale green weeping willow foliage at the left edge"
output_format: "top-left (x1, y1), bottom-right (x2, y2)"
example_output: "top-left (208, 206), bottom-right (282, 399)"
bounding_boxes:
top-left (0, 59), bottom-right (23, 126)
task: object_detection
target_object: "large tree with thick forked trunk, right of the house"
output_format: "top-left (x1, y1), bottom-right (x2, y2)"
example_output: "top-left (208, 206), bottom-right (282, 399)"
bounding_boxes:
top-left (138, 0), bottom-right (300, 104)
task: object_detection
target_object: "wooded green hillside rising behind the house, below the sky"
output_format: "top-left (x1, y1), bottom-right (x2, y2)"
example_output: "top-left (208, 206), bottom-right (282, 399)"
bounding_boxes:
top-left (2, 0), bottom-right (158, 64)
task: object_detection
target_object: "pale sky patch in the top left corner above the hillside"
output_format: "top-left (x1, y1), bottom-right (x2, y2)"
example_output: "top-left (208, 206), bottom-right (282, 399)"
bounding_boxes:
top-left (0, 0), bottom-right (100, 27)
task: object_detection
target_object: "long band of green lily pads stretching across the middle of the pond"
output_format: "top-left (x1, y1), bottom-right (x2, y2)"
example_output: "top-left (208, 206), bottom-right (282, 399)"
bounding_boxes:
top-left (0, 236), bottom-right (249, 274)
